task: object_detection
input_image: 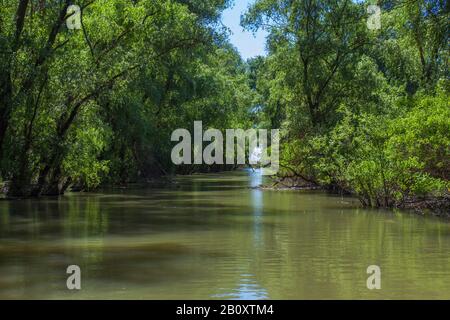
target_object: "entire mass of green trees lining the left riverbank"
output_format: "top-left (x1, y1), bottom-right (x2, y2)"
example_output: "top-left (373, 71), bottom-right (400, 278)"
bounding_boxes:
top-left (0, 0), bottom-right (252, 196)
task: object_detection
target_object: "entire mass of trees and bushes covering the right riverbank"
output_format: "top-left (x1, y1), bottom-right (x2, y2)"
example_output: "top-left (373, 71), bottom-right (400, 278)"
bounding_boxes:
top-left (243, 0), bottom-right (450, 207)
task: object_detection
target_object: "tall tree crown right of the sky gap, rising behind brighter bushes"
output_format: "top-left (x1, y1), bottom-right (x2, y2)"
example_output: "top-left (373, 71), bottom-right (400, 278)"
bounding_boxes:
top-left (242, 0), bottom-right (370, 127)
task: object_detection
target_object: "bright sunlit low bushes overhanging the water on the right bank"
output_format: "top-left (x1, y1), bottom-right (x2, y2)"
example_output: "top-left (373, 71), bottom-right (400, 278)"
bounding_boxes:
top-left (286, 87), bottom-right (450, 206)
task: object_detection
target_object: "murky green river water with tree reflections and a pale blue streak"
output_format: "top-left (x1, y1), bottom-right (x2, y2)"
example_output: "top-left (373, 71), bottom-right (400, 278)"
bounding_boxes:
top-left (0, 172), bottom-right (450, 299)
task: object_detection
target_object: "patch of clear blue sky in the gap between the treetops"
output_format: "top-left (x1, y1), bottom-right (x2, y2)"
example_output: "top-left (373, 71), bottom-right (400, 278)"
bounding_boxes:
top-left (222, 0), bottom-right (267, 59)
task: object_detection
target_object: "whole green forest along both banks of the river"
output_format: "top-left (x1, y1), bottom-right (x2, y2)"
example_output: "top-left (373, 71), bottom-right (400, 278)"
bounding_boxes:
top-left (0, 0), bottom-right (450, 212)
